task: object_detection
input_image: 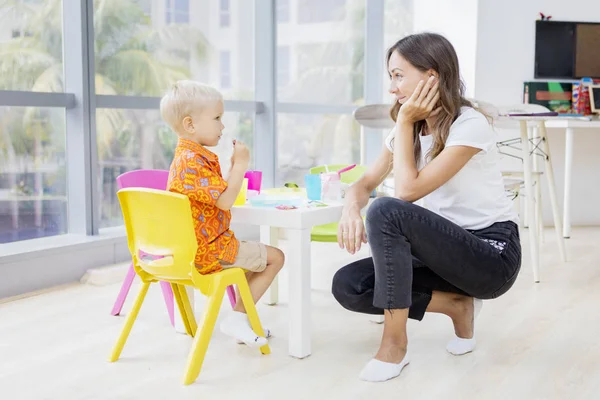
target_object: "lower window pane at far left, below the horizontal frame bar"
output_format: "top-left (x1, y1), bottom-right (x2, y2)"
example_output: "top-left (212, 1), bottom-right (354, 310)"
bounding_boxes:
top-left (0, 107), bottom-right (67, 243)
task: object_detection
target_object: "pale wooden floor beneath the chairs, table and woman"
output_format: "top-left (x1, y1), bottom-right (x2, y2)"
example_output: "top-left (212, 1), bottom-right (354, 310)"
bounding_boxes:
top-left (0, 228), bottom-right (600, 400)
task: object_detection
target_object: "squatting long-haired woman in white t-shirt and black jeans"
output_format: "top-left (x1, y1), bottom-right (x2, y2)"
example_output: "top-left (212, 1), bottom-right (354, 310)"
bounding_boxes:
top-left (332, 33), bottom-right (521, 381)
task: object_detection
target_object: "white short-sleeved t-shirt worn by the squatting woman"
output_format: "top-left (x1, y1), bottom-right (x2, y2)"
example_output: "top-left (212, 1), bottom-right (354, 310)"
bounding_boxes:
top-left (385, 107), bottom-right (517, 230)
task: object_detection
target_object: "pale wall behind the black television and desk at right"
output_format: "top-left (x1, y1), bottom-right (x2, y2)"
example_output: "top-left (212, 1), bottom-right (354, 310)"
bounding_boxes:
top-left (474, 0), bottom-right (600, 225)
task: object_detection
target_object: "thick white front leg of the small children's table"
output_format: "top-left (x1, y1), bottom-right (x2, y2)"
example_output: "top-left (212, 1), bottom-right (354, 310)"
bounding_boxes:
top-left (286, 229), bottom-right (311, 358)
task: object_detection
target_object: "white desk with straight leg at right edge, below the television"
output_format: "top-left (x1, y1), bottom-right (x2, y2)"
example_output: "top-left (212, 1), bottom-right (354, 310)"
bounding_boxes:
top-left (544, 117), bottom-right (600, 238)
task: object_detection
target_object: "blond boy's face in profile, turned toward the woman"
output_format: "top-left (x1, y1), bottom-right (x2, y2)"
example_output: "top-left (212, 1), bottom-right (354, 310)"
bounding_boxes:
top-left (183, 101), bottom-right (225, 147)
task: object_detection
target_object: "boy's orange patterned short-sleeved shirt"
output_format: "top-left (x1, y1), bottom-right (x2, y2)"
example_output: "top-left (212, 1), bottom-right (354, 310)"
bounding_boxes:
top-left (167, 139), bottom-right (239, 274)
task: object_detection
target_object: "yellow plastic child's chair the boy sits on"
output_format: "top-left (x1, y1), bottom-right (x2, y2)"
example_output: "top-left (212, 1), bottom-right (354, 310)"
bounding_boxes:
top-left (110, 188), bottom-right (271, 385)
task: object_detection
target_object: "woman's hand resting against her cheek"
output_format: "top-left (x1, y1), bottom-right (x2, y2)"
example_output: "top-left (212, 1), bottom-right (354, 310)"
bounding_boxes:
top-left (396, 76), bottom-right (440, 124)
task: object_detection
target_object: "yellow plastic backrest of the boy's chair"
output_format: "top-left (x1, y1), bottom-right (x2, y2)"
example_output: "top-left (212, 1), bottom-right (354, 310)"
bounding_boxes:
top-left (117, 188), bottom-right (199, 281)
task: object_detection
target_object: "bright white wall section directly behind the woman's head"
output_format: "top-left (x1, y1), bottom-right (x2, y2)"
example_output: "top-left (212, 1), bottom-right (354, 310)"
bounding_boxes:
top-left (413, 0), bottom-right (478, 97)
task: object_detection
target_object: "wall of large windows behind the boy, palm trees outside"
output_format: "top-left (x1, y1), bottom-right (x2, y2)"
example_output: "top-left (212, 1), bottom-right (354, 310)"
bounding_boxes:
top-left (0, 0), bottom-right (413, 243)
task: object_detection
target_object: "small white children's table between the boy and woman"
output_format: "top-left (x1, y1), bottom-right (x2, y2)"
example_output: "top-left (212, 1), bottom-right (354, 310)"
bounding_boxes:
top-left (175, 204), bottom-right (343, 358)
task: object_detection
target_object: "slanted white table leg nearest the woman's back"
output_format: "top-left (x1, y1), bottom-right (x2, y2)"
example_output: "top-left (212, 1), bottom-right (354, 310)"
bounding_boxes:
top-left (521, 121), bottom-right (540, 283)
